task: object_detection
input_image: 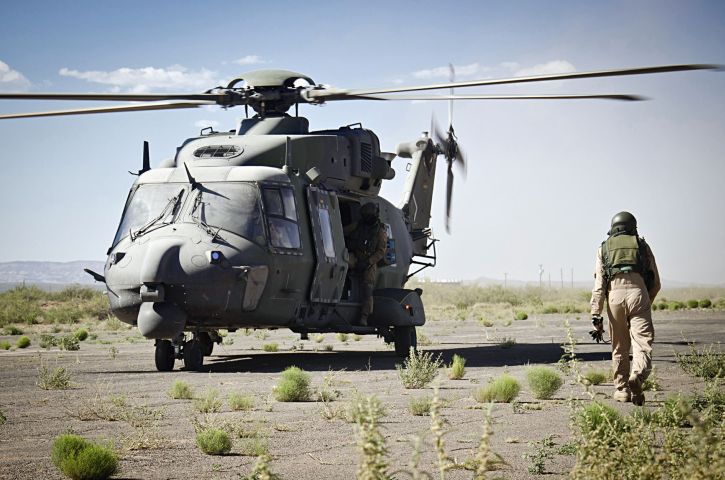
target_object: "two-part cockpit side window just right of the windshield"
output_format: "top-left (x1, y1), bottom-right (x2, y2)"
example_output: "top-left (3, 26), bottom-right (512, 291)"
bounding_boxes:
top-left (262, 186), bottom-right (302, 249)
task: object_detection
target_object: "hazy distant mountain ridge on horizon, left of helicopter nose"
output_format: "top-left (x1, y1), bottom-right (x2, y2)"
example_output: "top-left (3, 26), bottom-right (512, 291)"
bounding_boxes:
top-left (0, 260), bottom-right (104, 285)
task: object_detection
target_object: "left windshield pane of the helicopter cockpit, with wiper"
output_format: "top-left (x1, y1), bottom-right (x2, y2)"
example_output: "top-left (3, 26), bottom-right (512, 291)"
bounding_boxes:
top-left (113, 183), bottom-right (187, 246)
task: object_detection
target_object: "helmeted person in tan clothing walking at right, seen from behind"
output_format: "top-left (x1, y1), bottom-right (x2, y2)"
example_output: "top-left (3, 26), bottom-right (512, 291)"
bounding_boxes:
top-left (591, 212), bottom-right (660, 405)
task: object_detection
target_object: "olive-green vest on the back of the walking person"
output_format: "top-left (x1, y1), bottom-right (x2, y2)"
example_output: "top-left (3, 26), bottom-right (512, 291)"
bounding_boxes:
top-left (602, 234), bottom-right (651, 288)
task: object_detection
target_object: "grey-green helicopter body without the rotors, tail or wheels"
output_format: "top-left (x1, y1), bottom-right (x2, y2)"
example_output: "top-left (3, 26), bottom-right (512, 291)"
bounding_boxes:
top-left (104, 117), bottom-right (424, 339)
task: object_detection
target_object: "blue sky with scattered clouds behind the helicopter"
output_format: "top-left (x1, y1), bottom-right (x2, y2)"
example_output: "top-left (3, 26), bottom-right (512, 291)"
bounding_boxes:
top-left (0, 0), bottom-right (725, 286)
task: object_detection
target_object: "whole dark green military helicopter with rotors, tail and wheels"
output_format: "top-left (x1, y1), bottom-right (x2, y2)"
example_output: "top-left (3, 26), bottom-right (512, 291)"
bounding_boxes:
top-left (0, 64), bottom-right (719, 371)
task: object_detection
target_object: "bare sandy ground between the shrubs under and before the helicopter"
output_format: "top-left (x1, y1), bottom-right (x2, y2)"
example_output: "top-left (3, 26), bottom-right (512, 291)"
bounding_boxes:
top-left (0, 311), bottom-right (725, 479)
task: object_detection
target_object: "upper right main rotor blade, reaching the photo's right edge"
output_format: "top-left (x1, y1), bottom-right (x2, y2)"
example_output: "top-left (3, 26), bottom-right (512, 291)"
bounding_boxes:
top-left (310, 64), bottom-right (725, 99)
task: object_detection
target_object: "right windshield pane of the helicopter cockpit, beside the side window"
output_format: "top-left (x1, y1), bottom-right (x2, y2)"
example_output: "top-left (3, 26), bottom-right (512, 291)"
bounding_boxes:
top-left (184, 182), bottom-right (265, 245)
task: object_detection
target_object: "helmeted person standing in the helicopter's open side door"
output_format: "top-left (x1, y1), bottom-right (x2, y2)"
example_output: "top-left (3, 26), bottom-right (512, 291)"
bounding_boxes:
top-left (346, 202), bottom-right (388, 326)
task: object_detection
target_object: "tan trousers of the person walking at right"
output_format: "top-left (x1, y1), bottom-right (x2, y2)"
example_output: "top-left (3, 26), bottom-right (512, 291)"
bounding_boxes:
top-left (607, 273), bottom-right (655, 390)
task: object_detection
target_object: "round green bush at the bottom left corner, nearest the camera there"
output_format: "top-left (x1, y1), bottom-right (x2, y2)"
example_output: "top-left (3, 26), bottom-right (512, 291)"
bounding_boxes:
top-left (51, 434), bottom-right (118, 480)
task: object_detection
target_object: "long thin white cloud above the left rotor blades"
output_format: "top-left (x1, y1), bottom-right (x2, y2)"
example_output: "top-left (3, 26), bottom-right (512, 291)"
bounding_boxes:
top-left (58, 65), bottom-right (220, 93)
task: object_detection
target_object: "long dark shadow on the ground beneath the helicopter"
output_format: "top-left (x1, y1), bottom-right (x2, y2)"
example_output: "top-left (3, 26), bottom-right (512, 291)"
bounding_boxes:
top-left (203, 343), bottom-right (611, 373)
